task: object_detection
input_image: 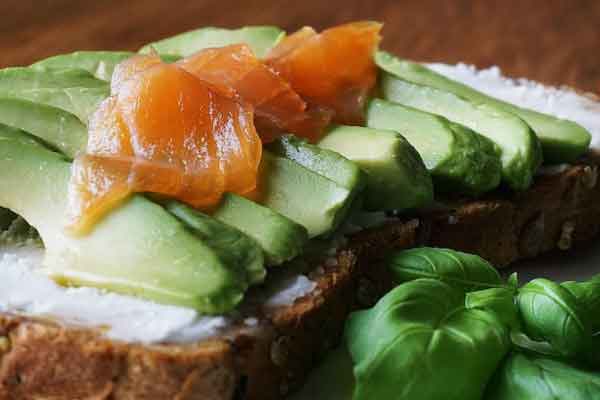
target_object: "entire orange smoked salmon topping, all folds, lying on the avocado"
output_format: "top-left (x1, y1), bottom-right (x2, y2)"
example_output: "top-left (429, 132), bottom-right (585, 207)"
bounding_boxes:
top-left (69, 22), bottom-right (381, 234)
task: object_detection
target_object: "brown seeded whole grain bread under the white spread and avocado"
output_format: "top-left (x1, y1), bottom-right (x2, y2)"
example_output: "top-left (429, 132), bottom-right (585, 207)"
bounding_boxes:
top-left (0, 155), bottom-right (600, 400)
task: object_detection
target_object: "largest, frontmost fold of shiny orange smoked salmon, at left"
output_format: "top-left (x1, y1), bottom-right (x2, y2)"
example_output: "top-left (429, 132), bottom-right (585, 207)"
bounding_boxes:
top-left (70, 56), bottom-right (262, 233)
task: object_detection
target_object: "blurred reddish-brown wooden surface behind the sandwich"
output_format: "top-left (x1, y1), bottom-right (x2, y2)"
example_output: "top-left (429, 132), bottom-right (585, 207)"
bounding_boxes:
top-left (0, 0), bottom-right (600, 93)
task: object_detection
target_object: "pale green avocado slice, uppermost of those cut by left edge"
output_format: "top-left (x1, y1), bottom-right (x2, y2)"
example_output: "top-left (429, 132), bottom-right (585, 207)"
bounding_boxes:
top-left (0, 68), bottom-right (110, 124)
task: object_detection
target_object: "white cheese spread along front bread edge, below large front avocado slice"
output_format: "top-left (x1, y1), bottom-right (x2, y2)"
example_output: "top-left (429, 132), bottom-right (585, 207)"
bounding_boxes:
top-left (0, 247), bottom-right (316, 343)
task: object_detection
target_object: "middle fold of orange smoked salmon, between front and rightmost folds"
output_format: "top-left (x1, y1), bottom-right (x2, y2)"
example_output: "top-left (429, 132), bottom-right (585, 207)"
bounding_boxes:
top-left (178, 44), bottom-right (331, 143)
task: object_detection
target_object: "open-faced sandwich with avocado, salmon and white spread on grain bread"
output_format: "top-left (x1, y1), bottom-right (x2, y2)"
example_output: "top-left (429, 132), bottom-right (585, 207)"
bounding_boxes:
top-left (0, 22), bottom-right (600, 400)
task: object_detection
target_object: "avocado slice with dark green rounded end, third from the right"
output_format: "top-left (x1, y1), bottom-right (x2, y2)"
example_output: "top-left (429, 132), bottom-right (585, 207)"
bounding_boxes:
top-left (367, 99), bottom-right (502, 196)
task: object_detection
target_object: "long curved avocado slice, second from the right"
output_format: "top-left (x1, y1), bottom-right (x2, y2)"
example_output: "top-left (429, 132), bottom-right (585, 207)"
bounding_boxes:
top-left (381, 73), bottom-right (542, 190)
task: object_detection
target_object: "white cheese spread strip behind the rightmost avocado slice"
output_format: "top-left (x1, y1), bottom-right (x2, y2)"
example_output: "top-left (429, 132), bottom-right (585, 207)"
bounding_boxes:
top-left (428, 64), bottom-right (600, 150)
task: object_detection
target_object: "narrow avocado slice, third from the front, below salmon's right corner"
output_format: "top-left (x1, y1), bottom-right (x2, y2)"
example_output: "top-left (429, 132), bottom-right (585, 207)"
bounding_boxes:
top-left (212, 193), bottom-right (308, 265)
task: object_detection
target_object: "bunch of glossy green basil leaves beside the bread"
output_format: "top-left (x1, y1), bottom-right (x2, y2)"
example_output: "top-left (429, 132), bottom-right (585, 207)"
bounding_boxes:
top-left (346, 248), bottom-right (600, 400)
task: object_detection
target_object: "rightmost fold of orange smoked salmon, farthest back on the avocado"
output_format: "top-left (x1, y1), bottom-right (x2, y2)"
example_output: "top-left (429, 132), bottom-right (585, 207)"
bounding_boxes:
top-left (267, 21), bottom-right (381, 125)
